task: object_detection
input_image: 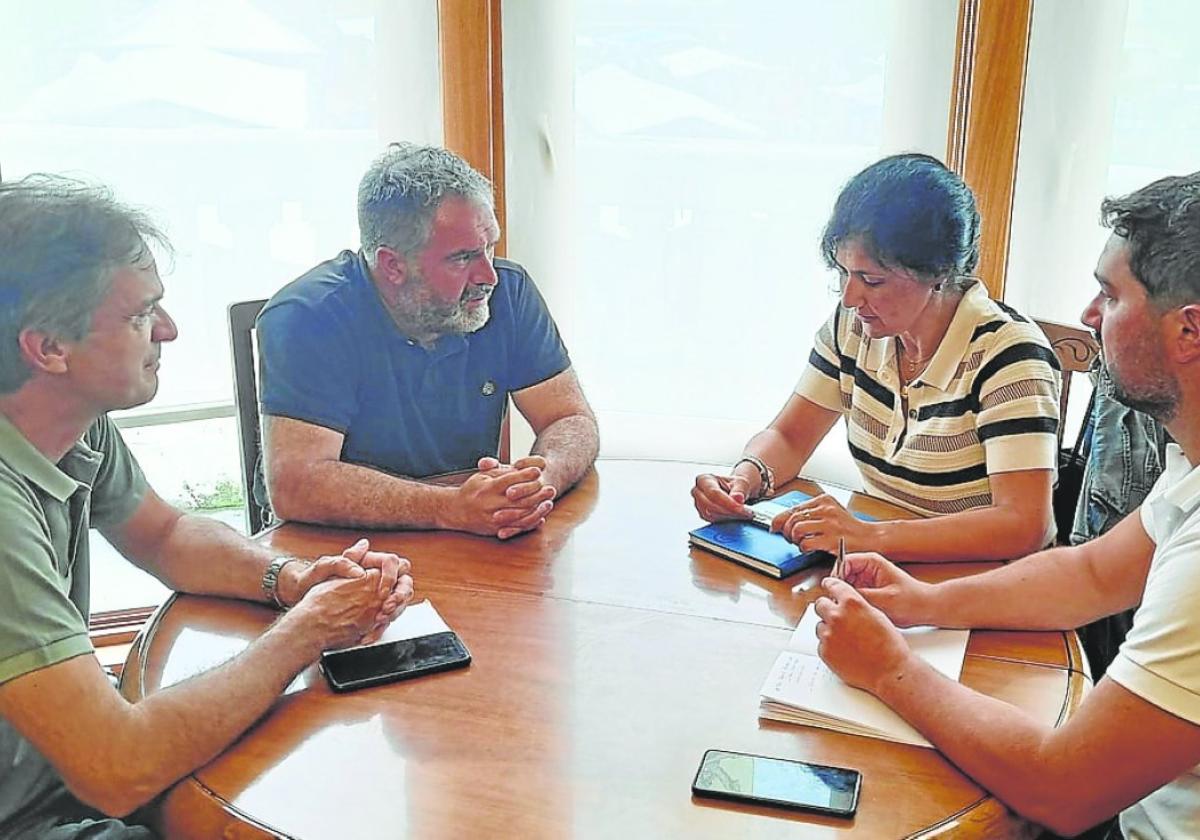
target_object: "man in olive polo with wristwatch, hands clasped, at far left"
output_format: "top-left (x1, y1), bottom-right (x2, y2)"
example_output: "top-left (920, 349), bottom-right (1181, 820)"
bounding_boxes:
top-left (0, 176), bottom-right (412, 840)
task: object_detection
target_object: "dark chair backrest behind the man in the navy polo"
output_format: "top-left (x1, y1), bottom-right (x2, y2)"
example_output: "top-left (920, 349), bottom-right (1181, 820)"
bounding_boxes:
top-left (228, 300), bottom-right (271, 534)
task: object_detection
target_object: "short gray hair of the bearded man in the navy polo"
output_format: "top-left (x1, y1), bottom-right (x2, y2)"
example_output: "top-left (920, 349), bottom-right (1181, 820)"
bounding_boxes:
top-left (359, 143), bottom-right (496, 263)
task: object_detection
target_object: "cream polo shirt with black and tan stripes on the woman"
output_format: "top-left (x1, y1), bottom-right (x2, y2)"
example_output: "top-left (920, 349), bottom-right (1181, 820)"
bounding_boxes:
top-left (796, 282), bottom-right (1062, 528)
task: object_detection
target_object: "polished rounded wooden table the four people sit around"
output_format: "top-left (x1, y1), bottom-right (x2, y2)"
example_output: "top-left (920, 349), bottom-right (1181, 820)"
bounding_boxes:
top-left (122, 461), bottom-right (1088, 840)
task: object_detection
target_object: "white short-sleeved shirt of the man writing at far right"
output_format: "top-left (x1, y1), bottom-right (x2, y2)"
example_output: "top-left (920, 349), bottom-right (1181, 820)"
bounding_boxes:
top-left (1108, 444), bottom-right (1200, 839)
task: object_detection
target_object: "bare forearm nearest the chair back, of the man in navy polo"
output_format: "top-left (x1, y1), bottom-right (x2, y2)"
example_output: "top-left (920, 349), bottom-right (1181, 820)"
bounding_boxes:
top-left (271, 461), bottom-right (455, 528)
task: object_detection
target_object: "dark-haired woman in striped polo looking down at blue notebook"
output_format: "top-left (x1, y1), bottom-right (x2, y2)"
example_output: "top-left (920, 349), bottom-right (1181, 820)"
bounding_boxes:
top-left (692, 154), bottom-right (1061, 562)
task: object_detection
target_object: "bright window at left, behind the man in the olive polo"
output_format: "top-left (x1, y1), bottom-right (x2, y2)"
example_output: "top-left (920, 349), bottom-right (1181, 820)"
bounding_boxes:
top-left (0, 0), bottom-right (440, 610)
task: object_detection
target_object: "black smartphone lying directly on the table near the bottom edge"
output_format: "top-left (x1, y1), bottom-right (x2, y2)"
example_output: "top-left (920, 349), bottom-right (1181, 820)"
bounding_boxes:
top-left (691, 750), bottom-right (863, 817)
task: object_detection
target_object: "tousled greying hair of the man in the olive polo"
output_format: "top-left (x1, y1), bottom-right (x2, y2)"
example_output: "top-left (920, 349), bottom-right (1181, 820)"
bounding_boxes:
top-left (0, 174), bottom-right (170, 394)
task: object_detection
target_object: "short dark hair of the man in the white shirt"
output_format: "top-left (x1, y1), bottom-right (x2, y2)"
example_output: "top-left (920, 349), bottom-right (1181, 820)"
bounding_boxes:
top-left (1100, 172), bottom-right (1200, 308)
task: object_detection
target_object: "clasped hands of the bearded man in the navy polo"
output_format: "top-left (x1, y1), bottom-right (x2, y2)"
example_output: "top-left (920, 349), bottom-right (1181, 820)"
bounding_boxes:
top-left (456, 455), bottom-right (558, 540)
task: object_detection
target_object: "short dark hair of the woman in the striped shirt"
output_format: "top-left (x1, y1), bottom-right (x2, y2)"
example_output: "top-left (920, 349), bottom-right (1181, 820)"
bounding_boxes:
top-left (821, 154), bottom-right (979, 282)
